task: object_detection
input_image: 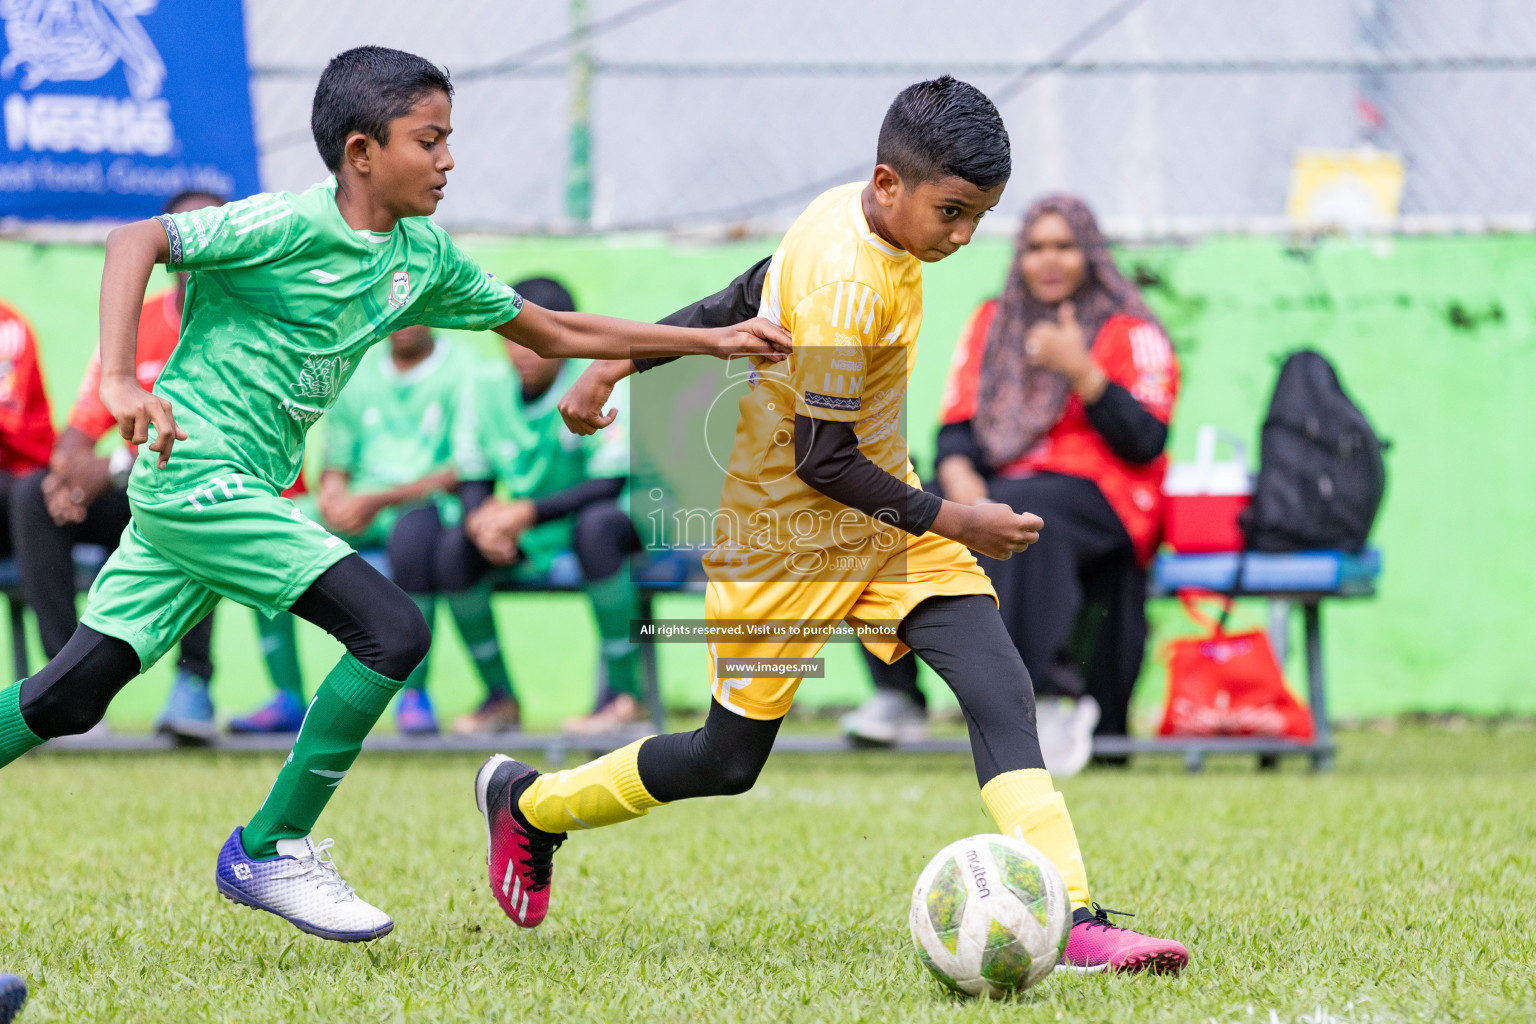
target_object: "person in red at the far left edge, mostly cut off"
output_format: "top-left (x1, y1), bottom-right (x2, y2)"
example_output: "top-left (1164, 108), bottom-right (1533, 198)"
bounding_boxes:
top-left (0, 302), bottom-right (54, 574)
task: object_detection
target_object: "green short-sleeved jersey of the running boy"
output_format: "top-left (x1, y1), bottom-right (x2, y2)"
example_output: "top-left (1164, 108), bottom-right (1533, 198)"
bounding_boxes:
top-left (132, 178), bottom-right (522, 494)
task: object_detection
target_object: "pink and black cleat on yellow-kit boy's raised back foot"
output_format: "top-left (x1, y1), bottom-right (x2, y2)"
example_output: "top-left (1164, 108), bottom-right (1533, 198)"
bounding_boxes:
top-left (475, 754), bottom-right (565, 927)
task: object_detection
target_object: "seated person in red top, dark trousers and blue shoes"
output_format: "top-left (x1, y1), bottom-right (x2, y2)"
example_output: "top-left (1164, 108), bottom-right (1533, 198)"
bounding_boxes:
top-left (8, 192), bottom-right (224, 743)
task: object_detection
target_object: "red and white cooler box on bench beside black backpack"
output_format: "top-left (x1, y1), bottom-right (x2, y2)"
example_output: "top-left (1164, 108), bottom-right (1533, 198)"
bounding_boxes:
top-left (1163, 425), bottom-right (1253, 554)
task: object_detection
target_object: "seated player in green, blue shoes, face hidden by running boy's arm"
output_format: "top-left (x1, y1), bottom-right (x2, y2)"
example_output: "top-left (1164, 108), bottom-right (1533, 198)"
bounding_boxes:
top-left (232, 325), bottom-right (518, 735)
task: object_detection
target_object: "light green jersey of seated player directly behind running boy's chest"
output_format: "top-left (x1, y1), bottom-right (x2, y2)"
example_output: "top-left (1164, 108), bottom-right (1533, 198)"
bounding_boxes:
top-left (324, 338), bottom-right (484, 491)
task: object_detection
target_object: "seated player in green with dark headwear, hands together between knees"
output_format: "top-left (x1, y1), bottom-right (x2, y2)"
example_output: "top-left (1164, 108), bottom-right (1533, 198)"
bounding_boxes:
top-left (390, 278), bottom-right (644, 732)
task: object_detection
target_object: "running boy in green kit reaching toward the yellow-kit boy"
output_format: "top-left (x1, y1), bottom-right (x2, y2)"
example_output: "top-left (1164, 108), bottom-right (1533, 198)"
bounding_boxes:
top-left (0, 46), bottom-right (790, 941)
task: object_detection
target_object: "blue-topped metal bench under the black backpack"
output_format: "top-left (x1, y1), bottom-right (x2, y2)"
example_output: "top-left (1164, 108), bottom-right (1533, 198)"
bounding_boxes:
top-left (1142, 548), bottom-right (1381, 771)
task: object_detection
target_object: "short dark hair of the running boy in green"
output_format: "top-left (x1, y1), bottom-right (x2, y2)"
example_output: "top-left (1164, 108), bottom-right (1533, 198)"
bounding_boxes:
top-left (309, 46), bottom-right (453, 172)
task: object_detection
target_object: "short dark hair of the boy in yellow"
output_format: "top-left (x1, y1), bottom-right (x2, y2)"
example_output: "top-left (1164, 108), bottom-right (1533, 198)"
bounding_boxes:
top-left (876, 75), bottom-right (1014, 189)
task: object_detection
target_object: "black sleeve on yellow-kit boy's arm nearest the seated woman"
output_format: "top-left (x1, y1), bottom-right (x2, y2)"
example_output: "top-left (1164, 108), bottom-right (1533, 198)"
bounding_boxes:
top-left (794, 416), bottom-right (943, 534)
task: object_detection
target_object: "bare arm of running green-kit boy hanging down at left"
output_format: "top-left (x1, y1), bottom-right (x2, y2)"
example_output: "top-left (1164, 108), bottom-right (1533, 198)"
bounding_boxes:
top-left (101, 221), bottom-right (187, 468)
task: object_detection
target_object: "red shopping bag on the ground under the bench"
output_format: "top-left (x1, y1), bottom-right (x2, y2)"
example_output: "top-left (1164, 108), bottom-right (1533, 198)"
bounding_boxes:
top-left (1158, 591), bottom-right (1312, 740)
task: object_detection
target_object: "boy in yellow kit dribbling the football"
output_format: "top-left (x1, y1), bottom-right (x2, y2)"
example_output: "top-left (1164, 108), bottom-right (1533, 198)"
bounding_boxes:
top-left (476, 75), bottom-right (1187, 972)
